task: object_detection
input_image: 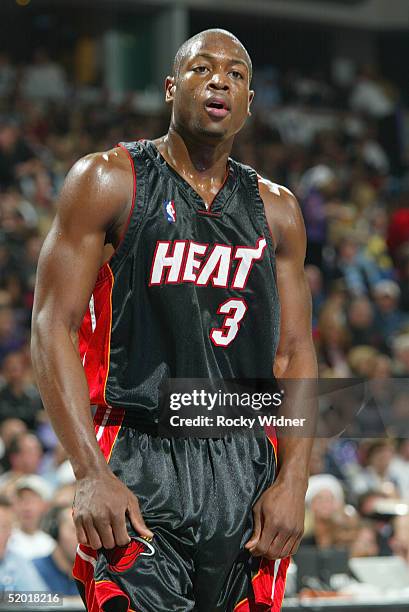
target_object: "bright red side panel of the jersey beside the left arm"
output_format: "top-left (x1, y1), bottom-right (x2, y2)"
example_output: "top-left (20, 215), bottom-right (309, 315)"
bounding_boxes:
top-left (79, 263), bottom-right (114, 406)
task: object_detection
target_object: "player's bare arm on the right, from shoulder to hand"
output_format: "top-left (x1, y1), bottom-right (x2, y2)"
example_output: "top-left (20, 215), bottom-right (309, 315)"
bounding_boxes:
top-left (246, 181), bottom-right (317, 559)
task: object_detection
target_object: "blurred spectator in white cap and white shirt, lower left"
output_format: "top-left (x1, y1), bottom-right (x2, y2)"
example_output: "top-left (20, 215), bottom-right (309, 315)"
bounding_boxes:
top-left (10, 474), bottom-right (55, 559)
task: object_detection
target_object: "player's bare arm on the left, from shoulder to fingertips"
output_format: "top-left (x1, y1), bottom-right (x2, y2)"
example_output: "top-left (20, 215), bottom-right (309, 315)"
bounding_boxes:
top-left (31, 149), bottom-right (153, 549)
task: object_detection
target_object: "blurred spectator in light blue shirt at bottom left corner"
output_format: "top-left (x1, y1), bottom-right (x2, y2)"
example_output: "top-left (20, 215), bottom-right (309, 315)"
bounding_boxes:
top-left (0, 496), bottom-right (46, 592)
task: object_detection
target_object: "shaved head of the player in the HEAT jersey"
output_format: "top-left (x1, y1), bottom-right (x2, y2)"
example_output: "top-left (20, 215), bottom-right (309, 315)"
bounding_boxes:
top-left (166, 29), bottom-right (254, 141)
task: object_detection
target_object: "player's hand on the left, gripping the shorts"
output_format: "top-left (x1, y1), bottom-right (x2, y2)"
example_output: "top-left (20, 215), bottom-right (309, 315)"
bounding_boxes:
top-left (73, 468), bottom-right (153, 549)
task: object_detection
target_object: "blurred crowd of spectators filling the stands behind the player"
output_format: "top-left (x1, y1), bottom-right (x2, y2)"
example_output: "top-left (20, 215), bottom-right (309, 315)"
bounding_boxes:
top-left (0, 50), bottom-right (409, 595)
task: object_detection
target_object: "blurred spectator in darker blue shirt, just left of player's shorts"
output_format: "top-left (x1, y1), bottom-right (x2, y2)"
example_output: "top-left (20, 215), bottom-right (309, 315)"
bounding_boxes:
top-left (33, 507), bottom-right (78, 596)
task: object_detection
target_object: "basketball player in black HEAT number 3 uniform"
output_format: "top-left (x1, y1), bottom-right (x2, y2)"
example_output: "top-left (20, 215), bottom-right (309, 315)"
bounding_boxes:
top-left (32, 30), bottom-right (316, 612)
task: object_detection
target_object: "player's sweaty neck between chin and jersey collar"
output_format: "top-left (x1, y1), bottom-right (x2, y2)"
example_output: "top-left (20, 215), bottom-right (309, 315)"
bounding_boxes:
top-left (158, 127), bottom-right (232, 184)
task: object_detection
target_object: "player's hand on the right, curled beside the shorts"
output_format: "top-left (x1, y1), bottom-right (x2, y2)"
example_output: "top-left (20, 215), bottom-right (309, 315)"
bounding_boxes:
top-left (245, 482), bottom-right (305, 559)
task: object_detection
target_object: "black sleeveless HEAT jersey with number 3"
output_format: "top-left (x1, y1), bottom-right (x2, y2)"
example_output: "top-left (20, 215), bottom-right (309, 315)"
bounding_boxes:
top-left (80, 141), bottom-right (280, 421)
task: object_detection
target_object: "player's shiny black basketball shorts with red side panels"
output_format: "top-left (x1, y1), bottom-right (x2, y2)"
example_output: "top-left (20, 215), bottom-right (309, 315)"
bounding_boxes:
top-left (73, 407), bottom-right (289, 612)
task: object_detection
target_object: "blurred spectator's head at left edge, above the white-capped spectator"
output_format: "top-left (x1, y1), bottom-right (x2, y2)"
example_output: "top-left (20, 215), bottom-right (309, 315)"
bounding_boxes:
top-left (0, 432), bottom-right (43, 493)
